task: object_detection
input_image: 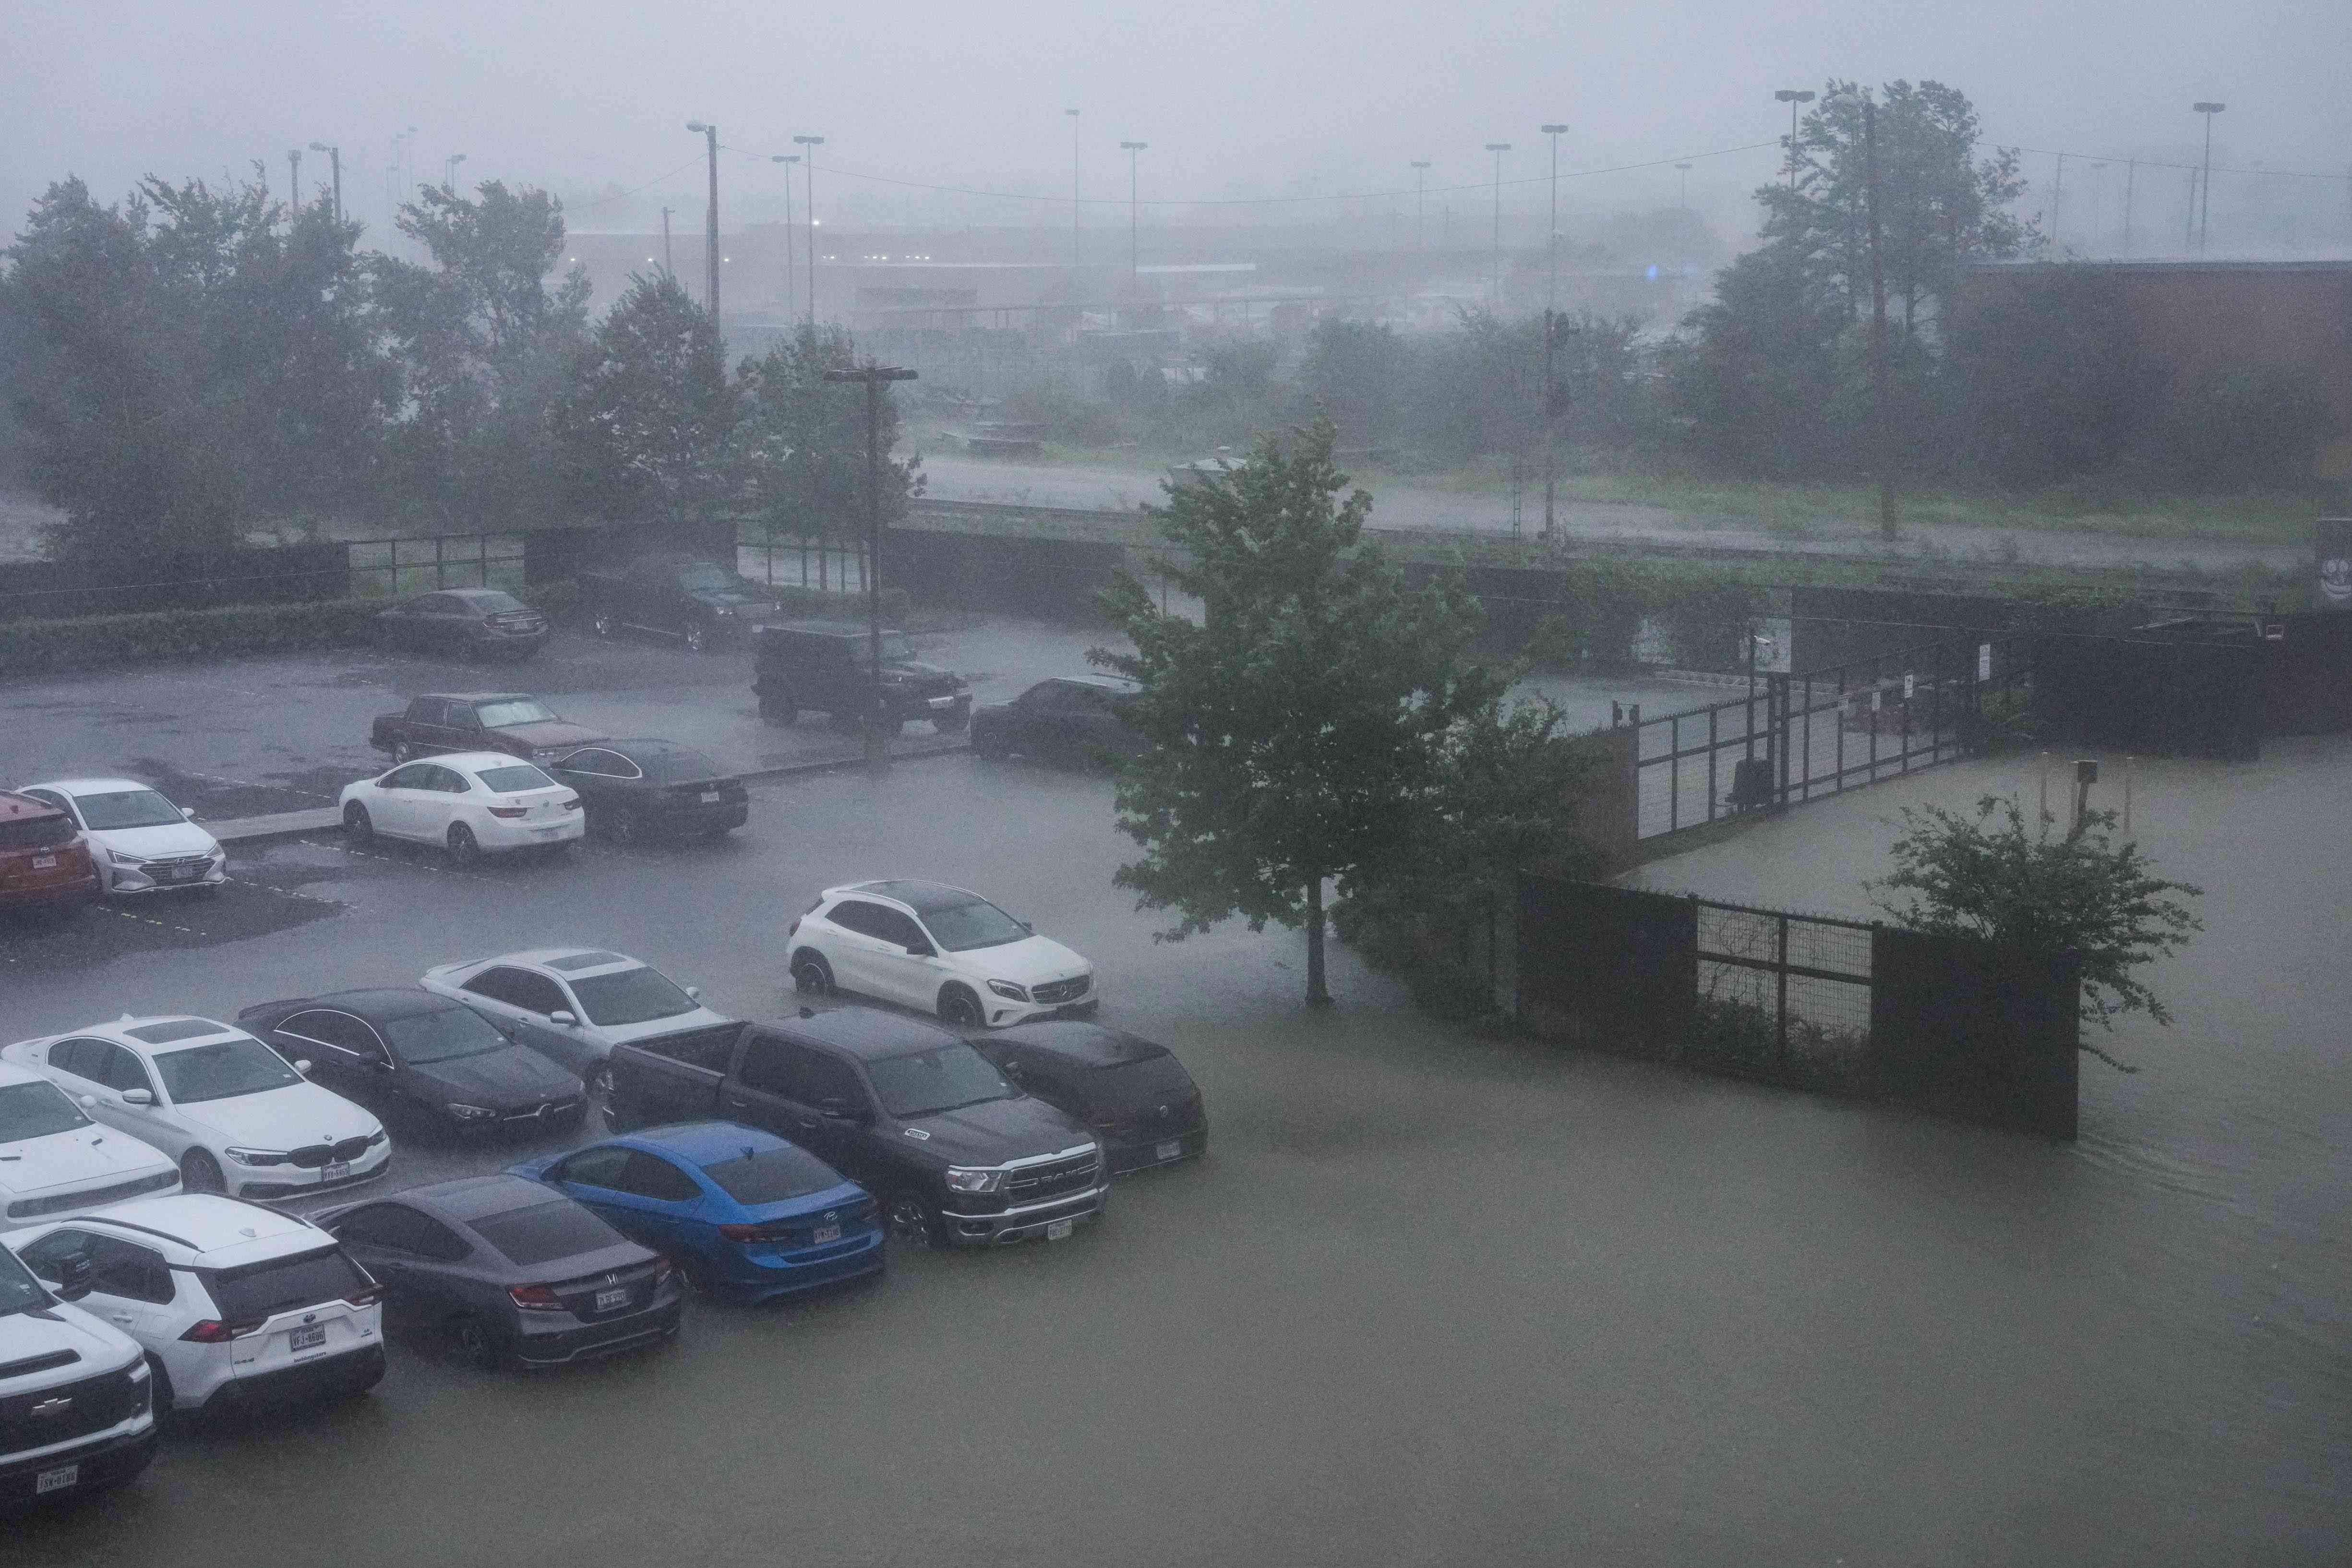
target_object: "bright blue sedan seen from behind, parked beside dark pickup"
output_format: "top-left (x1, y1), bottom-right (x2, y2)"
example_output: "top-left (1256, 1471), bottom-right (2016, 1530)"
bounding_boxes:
top-left (508, 1121), bottom-right (884, 1300)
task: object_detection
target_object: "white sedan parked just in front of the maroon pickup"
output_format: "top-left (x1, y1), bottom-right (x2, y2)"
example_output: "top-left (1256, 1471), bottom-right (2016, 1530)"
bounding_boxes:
top-left (341, 752), bottom-right (586, 865)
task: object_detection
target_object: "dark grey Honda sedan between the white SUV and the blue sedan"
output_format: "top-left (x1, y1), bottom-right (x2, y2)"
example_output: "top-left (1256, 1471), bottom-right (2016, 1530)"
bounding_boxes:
top-left (311, 1175), bottom-right (687, 1371)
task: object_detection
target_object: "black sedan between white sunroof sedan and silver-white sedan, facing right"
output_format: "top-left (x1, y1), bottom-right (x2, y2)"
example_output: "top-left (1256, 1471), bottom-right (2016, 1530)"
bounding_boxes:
top-left (238, 985), bottom-right (588, 1133)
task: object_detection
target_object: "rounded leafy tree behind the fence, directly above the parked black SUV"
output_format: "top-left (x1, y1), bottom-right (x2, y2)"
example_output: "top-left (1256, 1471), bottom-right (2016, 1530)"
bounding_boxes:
top-left (553, 273), bottom-right (741, 522)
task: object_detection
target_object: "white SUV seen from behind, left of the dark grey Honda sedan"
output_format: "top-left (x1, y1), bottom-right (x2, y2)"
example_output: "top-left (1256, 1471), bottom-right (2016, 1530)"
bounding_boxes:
top-left (0, 1192), bottom-right (384, 1411)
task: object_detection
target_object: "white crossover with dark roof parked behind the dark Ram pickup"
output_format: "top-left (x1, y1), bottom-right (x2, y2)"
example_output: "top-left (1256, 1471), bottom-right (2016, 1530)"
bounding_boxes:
top-left (786, 882), bottom-right (1098, 1029)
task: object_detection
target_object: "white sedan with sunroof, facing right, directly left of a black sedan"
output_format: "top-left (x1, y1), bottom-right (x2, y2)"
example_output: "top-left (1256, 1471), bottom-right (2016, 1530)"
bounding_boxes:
top-left (0, 1016), bottom-right (393, 1201)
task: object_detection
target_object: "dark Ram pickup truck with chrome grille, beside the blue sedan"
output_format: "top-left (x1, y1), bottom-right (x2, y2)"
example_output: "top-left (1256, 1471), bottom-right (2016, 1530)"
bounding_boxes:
top-left (604, 1006), bottom-right (1110, 1246)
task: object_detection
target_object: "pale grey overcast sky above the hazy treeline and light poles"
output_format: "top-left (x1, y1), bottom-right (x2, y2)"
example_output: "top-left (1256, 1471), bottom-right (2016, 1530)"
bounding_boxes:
top-left (0, 0), bottom-right (2352, 245)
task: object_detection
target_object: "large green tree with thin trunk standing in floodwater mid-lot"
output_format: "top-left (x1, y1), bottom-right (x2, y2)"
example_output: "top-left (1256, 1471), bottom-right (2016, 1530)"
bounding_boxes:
top-left (1089, 423), bottom-right (1500, 1006)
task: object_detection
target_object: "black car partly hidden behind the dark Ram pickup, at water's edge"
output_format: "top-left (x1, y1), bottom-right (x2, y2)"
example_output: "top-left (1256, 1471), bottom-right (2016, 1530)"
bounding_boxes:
top-left (972, 1020), bottom-right (1209, 1175)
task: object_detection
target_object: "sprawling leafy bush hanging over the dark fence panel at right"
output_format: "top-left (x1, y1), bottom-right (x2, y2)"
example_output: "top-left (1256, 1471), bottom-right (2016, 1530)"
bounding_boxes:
top-left (1863, 795), bottom-right (2204, 1072)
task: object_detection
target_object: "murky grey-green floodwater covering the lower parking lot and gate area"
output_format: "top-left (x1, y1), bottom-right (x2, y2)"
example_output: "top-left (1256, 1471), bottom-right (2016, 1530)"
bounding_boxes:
top-left (0, 743), bottom-right (2352, 1568)
